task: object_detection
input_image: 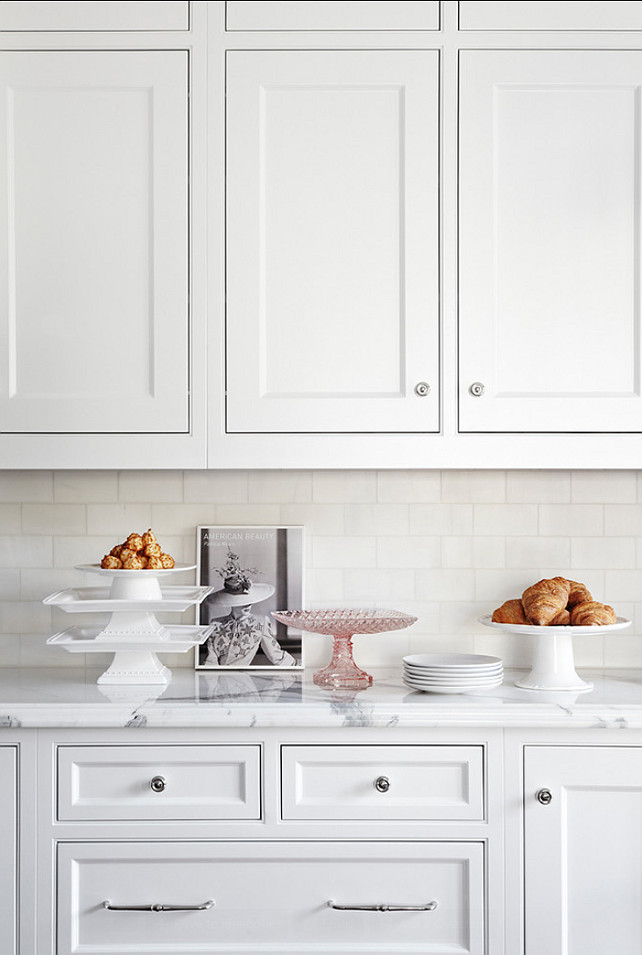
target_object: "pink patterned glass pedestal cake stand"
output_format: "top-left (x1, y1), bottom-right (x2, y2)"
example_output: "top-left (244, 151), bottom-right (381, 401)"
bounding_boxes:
top-left (272, 610), bottom-right (417, 690)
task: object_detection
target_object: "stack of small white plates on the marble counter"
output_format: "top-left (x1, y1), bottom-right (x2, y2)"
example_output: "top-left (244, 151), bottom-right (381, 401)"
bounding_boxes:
top-left (403, 653), bottom-right (504, 693)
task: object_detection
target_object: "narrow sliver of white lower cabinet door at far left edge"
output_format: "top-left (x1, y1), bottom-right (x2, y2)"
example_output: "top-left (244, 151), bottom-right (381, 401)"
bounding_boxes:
top-left (0, 746), bottom-right (18, 955)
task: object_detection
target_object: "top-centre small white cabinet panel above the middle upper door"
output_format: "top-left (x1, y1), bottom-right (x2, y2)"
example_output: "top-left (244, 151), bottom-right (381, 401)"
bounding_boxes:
top-left (226, 0), bottom-right (439, 30)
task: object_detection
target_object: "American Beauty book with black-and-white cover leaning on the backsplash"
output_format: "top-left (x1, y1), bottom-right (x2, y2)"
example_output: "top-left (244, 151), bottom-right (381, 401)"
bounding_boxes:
top-left (195, 525), bottom-right (304, 670)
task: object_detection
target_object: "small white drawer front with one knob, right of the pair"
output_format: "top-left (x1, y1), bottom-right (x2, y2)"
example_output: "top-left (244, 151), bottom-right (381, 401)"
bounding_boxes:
top-left (281, 746), bottom-right (484, 821)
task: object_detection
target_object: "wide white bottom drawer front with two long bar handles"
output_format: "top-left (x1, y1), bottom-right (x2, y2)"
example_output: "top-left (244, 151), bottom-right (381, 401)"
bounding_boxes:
top-left (57, 842), bottom-right (486, 955)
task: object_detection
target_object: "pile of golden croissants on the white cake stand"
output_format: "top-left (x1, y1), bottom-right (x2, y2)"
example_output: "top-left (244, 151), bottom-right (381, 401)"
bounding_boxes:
top-left (491, 577), bottom-right (617, 627)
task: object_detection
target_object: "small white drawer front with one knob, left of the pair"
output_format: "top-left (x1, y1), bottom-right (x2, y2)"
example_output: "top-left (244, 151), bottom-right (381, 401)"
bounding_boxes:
top-left (57, 746), bottom-right (261, 822)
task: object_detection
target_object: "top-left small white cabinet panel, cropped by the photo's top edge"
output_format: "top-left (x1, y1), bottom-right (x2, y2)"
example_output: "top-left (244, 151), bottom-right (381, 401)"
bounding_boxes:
top-left (0, 0), bottom-right (189, 31)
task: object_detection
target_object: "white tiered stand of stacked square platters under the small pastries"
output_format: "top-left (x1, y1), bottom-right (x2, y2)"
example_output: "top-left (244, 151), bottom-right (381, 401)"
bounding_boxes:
top-left (43, 564), bottom-right (213, 686)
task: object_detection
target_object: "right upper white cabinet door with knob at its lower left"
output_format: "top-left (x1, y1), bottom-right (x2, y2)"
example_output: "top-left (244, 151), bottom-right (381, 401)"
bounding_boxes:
top-left (459, 50), bottom-right (642, 432)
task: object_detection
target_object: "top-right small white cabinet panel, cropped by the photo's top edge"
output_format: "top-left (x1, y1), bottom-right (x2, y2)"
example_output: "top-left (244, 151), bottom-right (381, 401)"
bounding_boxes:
top-left (459, 0), bottom-right (642, 30)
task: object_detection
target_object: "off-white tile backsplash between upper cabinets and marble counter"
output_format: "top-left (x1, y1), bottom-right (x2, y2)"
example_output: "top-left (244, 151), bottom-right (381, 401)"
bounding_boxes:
top-left (0, 471), bottom-right (642, 667)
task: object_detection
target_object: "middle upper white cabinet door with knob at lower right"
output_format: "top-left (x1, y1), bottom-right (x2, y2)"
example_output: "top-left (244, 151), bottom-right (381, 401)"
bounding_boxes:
top-left (227, 51), bottom-right (439, 432)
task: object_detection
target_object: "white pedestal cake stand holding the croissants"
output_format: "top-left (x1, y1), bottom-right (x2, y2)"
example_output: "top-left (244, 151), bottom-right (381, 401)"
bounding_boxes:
top-left (479, 613), bottom-right (631, 693)
